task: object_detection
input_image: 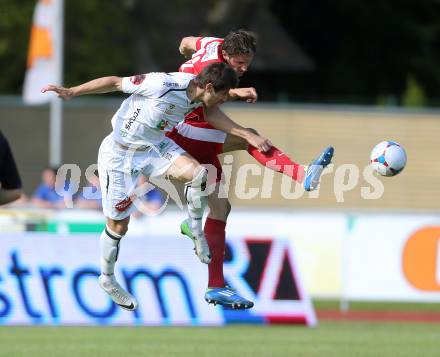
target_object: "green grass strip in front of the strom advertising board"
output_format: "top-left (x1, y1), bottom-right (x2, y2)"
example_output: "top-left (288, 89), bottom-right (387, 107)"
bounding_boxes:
top-left (0, 322), bottom-right (440, 357)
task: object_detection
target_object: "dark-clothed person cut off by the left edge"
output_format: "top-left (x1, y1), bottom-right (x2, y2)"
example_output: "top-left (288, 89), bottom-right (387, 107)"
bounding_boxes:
top-left (0, 131), bottom-right (22, 205)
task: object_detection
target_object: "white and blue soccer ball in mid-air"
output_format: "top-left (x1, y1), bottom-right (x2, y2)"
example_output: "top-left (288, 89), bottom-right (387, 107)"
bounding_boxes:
top-left (370, 141), bottom-right (406, 176)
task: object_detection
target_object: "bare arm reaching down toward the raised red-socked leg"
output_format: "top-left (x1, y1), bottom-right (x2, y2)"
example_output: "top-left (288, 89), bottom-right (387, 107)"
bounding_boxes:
top-left (205, 106), bottom-right (272, 152)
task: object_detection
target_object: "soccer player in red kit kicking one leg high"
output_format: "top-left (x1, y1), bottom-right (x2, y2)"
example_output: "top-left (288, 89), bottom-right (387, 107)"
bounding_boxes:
top-left (168, 30), bottom-right (333, 309)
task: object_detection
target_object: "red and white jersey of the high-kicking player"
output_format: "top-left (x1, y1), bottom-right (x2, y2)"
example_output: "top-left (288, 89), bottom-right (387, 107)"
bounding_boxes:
top-left (176, 37), bottom-right (226, 143)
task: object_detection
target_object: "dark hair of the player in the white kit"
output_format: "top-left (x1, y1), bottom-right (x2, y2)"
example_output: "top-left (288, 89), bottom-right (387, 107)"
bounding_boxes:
top-left (194, 62), bottom-right (238, 92)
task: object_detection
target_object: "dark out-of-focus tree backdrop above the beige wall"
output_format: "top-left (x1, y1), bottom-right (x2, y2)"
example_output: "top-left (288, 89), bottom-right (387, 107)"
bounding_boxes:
top-left (0, 0), bottom-right (440, 103)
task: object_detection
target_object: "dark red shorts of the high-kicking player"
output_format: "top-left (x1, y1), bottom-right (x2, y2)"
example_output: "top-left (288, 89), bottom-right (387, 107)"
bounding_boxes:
top-left (167, 128), bottom-right (223, 182)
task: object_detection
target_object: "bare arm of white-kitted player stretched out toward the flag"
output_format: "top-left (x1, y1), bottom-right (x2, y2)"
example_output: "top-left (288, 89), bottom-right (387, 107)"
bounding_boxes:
top-left (41, 76), bottom-right (122, 99)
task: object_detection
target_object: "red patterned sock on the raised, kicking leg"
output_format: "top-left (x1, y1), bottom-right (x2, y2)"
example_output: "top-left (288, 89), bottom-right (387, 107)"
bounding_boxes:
top-left (248, 145), bottom-right (304, 182)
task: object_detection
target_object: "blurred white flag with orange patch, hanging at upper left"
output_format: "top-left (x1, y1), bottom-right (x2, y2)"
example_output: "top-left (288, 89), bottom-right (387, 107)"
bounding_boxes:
top-left (23, 0), bottom-right (63, 104)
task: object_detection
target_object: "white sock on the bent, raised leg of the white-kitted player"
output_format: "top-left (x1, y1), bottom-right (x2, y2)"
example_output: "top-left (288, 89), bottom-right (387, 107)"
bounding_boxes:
top-left (185, 168), bottom-right (208, 235)
